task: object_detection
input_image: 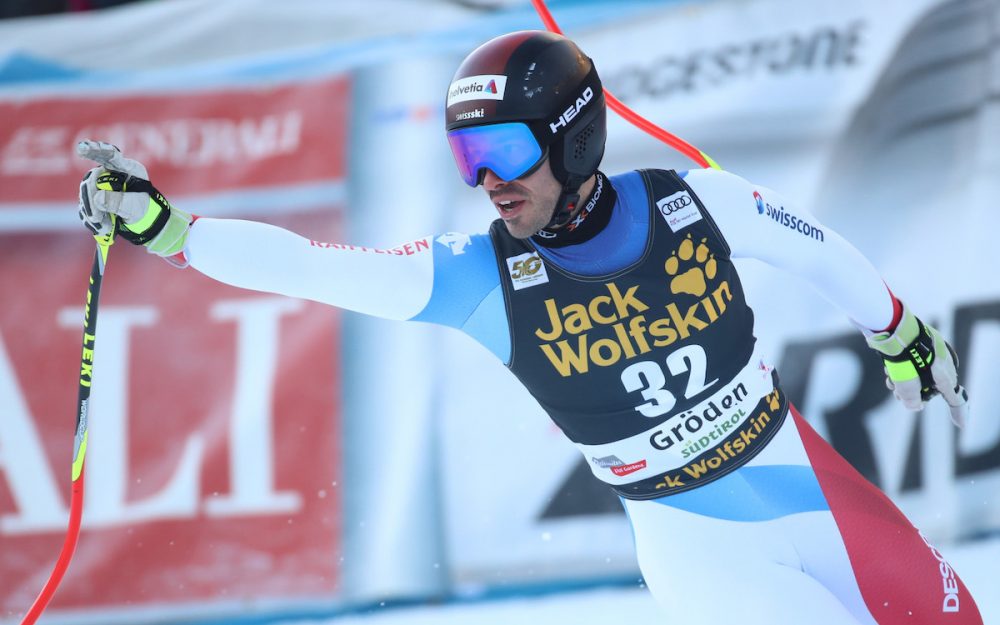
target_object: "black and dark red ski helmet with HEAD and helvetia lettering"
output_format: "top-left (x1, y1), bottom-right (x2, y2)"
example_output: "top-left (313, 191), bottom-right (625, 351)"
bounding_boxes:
top-left (445, 30), bottom-right (607, 226)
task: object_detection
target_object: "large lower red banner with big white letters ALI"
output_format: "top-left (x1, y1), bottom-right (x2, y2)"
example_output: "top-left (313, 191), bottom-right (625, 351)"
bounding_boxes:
top-left (0, 214), bottom-right (340, 614)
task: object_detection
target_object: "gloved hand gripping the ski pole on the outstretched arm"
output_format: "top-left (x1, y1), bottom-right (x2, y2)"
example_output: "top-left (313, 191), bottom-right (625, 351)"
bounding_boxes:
top-left (76, 140), bottom-right (192, 264)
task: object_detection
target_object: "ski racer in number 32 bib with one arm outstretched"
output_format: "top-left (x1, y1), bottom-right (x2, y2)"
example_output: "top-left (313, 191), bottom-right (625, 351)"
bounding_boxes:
top-left (78, 31), bottom-right (982, 625)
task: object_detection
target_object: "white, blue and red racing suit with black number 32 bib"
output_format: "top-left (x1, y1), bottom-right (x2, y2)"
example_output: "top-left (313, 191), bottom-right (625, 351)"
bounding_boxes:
top-left (185, 170), bottom-right (982, 625)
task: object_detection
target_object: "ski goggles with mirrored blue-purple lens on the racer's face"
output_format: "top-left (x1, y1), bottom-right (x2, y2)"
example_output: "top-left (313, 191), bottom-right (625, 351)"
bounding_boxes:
top-left (448, 122), bottom-right (545, 187)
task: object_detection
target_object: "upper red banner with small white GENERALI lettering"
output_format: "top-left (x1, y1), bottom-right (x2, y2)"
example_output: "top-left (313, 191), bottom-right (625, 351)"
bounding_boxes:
top-left (0, 78), bottom-right (349, 203)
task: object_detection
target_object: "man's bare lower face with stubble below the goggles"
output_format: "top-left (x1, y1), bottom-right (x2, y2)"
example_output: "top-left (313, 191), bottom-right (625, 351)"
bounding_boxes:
top-left (483, 159), bottom-right (562, 239)
